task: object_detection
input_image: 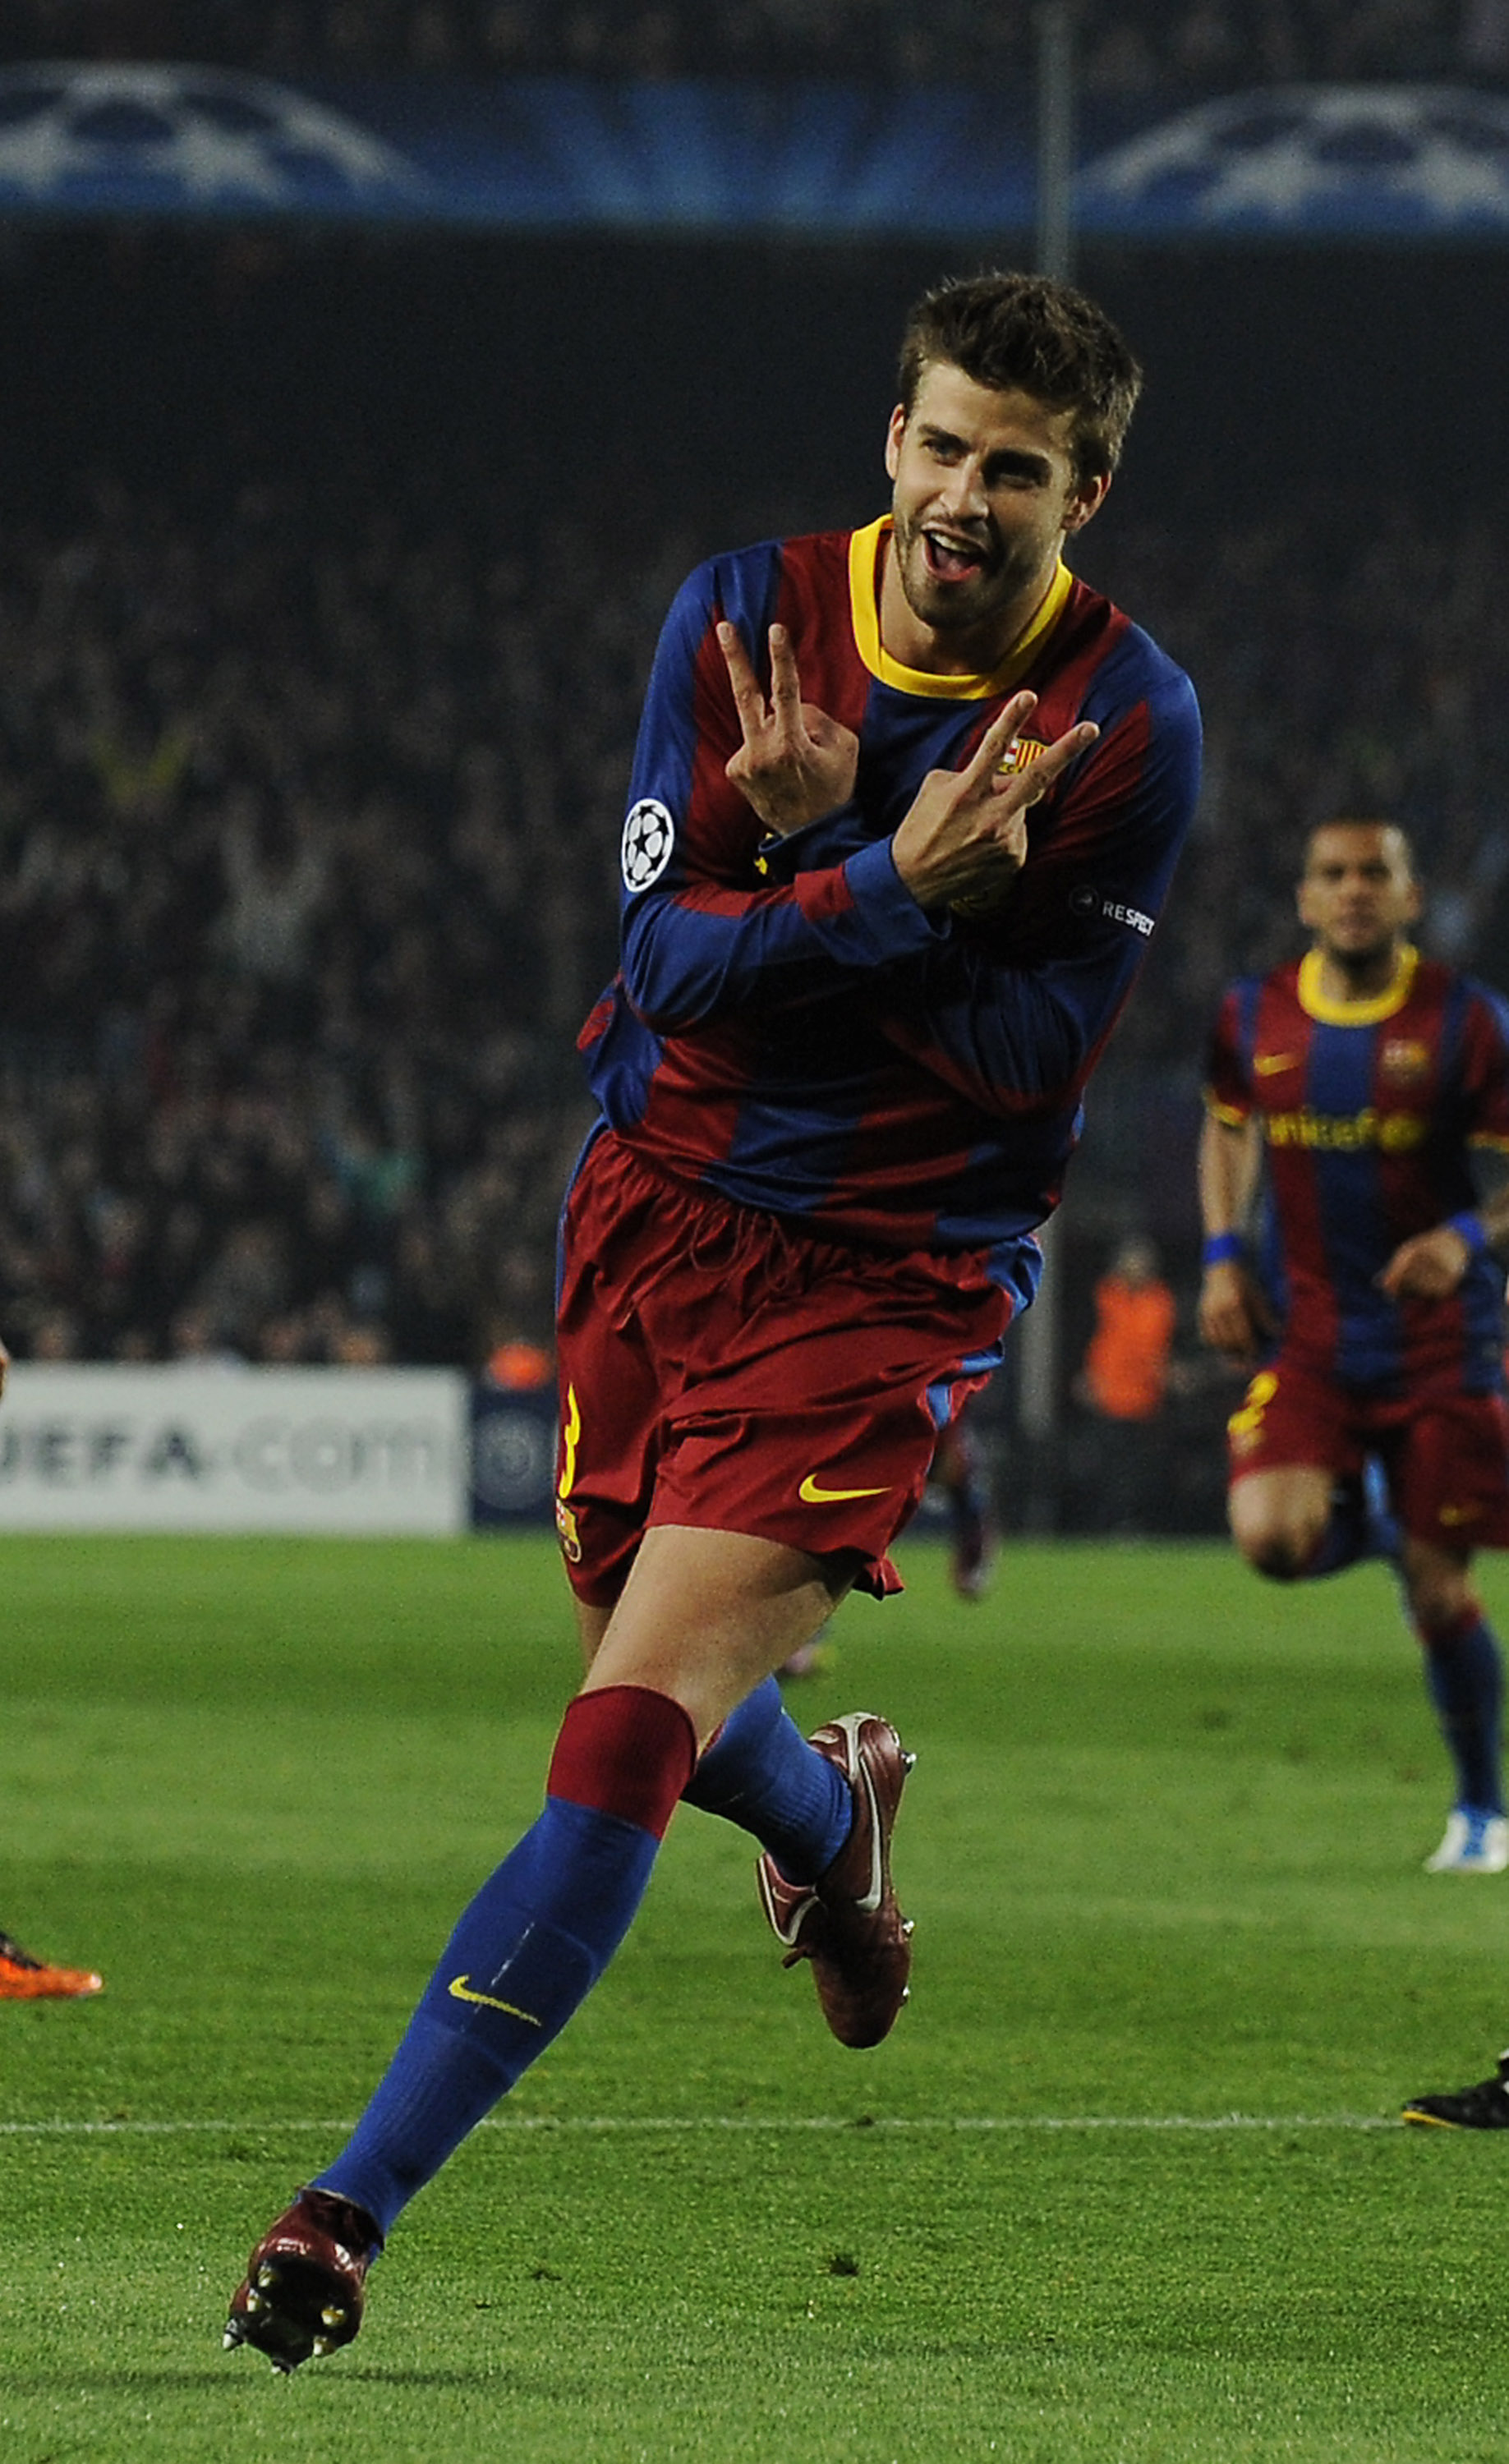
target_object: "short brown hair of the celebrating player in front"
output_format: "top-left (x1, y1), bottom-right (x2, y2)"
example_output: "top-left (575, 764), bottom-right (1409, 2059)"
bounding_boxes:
top-left (900, 274), bottom-right (1142, 480)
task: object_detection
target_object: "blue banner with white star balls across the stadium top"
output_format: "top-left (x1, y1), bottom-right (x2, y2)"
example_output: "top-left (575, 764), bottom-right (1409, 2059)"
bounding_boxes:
top-left (0, 62), bottom-right (1509, 241)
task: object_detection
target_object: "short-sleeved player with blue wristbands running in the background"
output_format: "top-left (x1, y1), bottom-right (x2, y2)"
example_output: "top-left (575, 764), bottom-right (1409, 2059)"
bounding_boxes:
top-left (1201, 821), bottom-right (1509, 1873)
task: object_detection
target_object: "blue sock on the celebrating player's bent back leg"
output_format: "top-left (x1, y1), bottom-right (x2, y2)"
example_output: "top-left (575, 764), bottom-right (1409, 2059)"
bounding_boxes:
top-left (680, 1678), bottom-right (853, 1882)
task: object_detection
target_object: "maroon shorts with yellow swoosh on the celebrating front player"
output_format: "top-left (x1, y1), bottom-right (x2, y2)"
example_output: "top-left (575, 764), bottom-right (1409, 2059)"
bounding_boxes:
top-left (557, 1133), bottom-right (1016, 1607)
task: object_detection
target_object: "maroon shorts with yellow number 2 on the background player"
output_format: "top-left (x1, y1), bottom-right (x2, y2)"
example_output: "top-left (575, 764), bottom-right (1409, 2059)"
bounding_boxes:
top-left (1226, 1353), bottom-right (1509, 1555)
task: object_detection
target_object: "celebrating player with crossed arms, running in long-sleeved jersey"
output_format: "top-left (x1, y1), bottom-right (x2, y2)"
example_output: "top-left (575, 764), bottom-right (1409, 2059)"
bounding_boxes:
top-left (227, 274), bottom-right (1198, 2368)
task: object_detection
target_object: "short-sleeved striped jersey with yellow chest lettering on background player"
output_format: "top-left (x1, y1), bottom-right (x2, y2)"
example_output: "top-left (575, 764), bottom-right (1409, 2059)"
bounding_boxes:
top-left (1208, 949), bottom-right (1509, 1392)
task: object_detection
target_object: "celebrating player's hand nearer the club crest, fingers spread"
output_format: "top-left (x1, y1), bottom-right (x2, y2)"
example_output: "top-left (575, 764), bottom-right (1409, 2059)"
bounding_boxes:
top-left (890, 692), bottom-right (1100, 907)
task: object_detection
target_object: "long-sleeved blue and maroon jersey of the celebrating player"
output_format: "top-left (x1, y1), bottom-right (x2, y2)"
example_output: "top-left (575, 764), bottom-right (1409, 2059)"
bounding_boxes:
top-left (582, 520), bottom-right (1198, 1249)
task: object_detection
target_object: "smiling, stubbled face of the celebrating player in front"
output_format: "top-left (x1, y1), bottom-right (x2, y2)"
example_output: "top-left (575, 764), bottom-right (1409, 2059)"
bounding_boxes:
top-left (886, 360), bottom-right (1102, 665)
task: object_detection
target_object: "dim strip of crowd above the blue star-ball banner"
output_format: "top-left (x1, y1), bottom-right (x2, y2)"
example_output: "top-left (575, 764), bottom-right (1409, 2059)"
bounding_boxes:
top-left (0, 0), bottom-right (1509, 101)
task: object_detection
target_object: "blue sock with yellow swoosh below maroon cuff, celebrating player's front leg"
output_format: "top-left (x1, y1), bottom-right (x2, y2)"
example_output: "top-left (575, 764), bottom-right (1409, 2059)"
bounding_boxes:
top-left (315, 1796), bottom-right (660, 2235)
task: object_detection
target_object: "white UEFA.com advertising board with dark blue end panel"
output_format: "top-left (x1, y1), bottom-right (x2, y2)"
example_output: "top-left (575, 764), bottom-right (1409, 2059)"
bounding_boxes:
top-left (0, 1360), bottom-right (554, 1538)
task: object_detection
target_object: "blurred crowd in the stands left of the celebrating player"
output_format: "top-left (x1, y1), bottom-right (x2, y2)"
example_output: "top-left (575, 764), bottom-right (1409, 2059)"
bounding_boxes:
top-left (0, 466), bottom-right (670, 1363)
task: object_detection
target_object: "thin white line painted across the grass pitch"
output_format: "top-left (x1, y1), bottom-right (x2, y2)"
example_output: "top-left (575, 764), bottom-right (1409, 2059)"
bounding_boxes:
top-left (0, 2114), bottom-right (1401, 2139)
